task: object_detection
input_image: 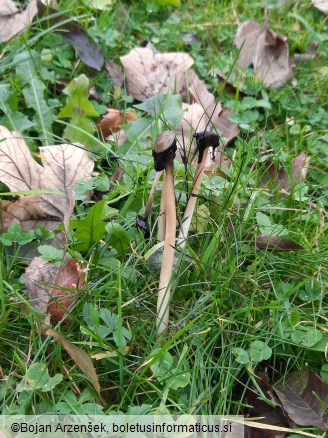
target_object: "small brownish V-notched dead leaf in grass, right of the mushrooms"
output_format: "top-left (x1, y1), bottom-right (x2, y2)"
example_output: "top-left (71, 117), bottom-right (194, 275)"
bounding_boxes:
top-left (261, 152), bottom-right (311, 190)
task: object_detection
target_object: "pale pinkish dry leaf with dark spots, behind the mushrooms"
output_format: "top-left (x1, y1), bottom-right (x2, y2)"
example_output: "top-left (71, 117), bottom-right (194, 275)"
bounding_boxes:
top-left (120, 47), bottom-right (194, 101)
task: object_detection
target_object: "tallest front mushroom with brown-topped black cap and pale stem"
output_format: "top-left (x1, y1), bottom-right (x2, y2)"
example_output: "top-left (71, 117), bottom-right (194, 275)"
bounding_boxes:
top-left (153, 131), bottom-right (177, 334)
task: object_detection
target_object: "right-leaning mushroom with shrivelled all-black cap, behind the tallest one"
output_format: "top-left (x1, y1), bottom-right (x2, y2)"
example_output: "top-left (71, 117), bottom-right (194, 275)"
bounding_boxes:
top-left (177, 131), bottom-right (219, 250)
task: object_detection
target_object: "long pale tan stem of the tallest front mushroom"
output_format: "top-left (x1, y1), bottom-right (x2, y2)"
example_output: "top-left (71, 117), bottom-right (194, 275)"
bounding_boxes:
top-left (157, 160), bottom-right (176, 334)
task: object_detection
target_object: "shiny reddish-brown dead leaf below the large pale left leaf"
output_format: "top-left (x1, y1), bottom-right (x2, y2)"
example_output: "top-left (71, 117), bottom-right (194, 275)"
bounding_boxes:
top-left (48, 259), bottom-right (83, 323)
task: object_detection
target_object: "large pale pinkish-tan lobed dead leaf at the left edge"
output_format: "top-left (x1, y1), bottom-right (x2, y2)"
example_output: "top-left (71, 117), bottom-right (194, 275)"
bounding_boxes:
top-left (0, 126), bottom-right (94, 230)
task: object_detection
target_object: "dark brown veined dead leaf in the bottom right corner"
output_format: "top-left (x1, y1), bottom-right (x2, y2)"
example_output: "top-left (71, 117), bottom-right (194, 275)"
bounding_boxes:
top-left (274, 368), bottom-right (328, 430)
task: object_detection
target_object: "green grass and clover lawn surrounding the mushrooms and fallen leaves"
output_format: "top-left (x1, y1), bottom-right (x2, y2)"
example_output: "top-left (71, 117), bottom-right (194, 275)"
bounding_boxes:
top-left (0, 0), bottom-right (328, 428)
